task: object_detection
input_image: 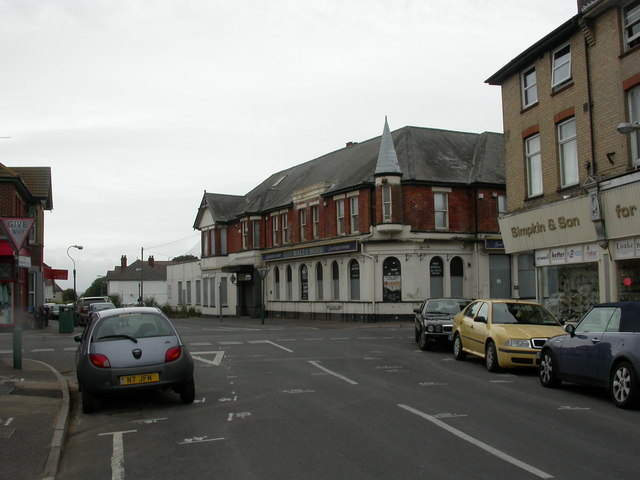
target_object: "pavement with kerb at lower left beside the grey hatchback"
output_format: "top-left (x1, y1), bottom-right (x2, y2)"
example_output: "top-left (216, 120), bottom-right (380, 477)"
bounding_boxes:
top-left (0, 322), bottom-right (70, 480)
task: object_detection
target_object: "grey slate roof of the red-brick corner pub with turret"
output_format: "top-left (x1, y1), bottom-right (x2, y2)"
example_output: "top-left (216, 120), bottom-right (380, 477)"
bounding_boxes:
top-left (194, 126), bottom-right (505, 229)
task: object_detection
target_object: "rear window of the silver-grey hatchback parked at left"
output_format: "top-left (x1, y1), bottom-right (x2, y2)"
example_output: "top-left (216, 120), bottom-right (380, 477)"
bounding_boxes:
top-left (93, 313), bottom-right (175, 341)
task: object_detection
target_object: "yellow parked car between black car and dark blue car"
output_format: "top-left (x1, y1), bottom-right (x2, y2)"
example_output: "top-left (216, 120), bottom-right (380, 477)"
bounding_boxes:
top-left (453, 300), bottom-right (565, 372)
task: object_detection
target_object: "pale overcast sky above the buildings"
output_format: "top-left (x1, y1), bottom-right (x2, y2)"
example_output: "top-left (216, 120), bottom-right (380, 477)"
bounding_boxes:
top-left (0, 0), bottom-right (577, 294)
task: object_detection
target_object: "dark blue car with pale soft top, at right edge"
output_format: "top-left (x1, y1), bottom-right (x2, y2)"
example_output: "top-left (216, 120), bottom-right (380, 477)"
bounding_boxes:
top-left (539, 301), bottom-right (640, 408)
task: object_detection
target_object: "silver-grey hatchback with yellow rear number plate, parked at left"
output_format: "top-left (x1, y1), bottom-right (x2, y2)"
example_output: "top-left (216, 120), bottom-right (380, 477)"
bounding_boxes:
top-left (75, 307), bottom-right (195, 413)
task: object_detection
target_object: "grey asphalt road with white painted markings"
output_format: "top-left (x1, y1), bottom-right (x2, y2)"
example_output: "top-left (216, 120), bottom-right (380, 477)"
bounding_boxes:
top-left (8, 319), bottom-right (640, 480)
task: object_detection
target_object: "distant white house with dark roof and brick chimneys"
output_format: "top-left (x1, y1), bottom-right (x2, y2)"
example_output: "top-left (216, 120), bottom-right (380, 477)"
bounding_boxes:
top-left (106, 255), bottom-right (172, 306)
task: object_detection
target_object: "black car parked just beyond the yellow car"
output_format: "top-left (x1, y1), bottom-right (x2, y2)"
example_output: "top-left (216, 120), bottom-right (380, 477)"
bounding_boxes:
top-left (413, 298), bottom-right (471, 350)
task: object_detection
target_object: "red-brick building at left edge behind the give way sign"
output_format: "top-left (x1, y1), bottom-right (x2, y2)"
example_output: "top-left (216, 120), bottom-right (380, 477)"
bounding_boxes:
top-left (0, 164), bottom-right (53, 326)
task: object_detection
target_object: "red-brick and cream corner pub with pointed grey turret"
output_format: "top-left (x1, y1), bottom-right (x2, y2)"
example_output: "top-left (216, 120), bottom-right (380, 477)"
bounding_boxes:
top-left (167, 121), bottom-right (510, 321)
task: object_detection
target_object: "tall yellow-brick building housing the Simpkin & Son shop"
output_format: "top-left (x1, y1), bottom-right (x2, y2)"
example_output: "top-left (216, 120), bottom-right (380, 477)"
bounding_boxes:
top-left (487, 0), bottom-right (640, 320)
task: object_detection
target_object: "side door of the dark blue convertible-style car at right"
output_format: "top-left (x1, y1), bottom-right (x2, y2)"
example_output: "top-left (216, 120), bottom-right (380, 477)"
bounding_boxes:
top-left (558, 306), bottom-right (619, 385)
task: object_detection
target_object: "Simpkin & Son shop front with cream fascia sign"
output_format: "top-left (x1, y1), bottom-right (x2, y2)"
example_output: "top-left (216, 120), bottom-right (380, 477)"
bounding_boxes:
top-left (500, 173), bottom-right (640, 321)
